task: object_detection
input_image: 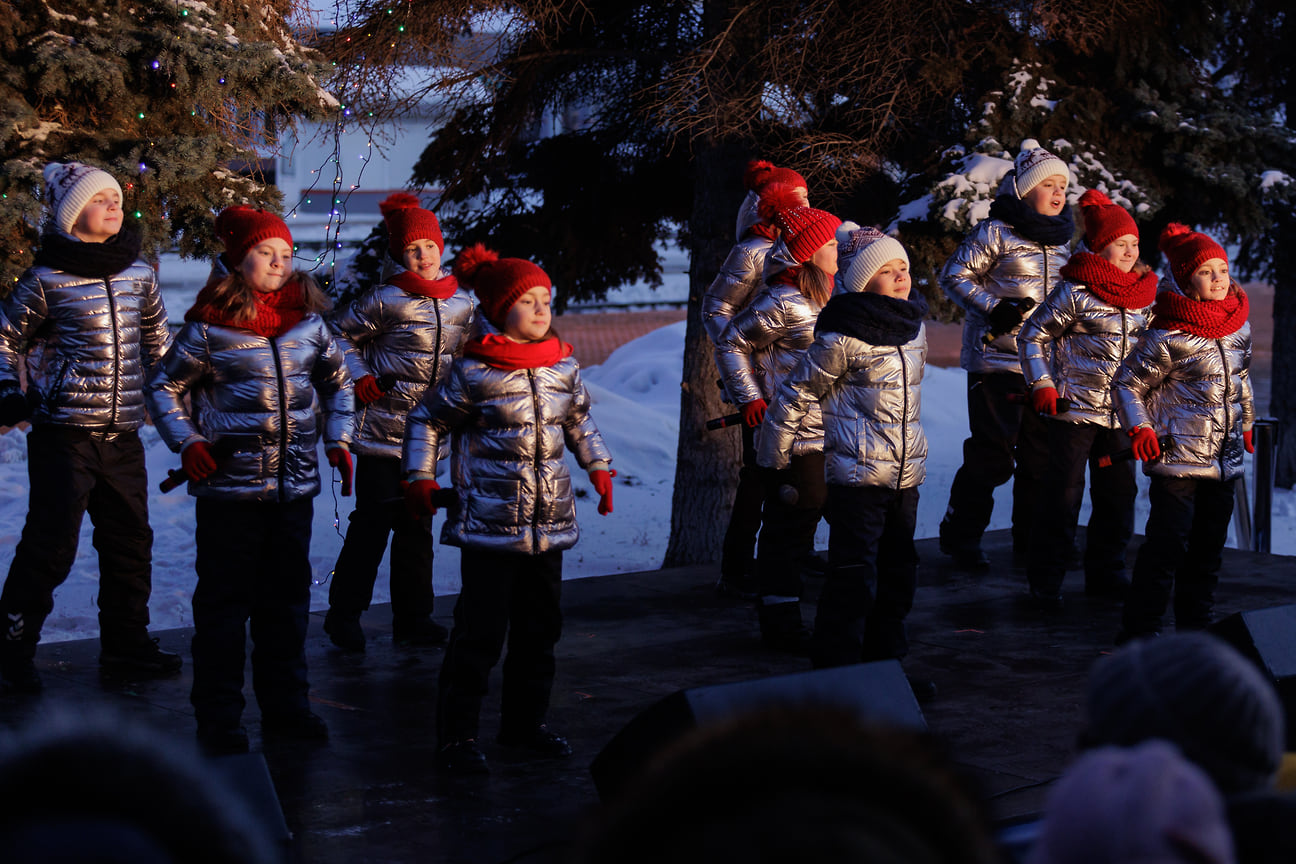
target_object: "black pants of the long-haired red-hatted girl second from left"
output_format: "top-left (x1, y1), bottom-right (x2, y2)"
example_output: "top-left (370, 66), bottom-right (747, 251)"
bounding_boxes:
top-left (189, 497), bottom-right (314, 728)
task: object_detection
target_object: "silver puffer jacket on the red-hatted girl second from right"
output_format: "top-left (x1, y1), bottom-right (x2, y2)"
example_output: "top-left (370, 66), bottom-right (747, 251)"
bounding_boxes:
top-left (1017, 280), bottom-right (1151, 429)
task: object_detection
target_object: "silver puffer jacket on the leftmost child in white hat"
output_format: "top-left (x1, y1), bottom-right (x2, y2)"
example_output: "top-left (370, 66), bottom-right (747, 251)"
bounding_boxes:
top-left (0, 260), bottom-right (170, 433)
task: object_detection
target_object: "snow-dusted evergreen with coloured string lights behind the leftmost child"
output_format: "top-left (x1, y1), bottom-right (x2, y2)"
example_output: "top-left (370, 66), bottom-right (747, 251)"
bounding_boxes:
top-left (0, 0), bottom-right (337, 290)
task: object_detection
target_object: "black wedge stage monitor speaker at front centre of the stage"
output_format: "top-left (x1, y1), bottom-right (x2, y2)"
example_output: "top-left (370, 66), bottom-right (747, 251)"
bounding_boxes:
top-left (590, 661), bottom-right (927, 801)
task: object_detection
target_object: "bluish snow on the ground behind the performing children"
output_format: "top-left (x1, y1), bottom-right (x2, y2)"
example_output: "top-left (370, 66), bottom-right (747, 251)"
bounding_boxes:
top-left (0, 323), bottom-right (1296, 641)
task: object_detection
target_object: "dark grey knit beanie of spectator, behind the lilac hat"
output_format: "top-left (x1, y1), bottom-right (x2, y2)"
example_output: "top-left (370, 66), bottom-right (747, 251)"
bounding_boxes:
top-left (1082, 632), bottom-right (1286, 795)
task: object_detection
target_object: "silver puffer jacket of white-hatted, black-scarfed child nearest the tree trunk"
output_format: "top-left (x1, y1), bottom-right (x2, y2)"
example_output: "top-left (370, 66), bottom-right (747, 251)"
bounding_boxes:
top-left (757, 326), bottom-right (927, 488)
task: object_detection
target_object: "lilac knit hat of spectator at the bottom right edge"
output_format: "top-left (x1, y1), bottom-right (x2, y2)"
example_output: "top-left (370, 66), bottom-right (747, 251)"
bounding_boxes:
top-left (1026, 741), bottom-right (1235, 864)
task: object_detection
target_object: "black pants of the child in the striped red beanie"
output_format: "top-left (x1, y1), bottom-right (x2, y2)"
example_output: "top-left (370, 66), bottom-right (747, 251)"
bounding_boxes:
top-left (756, 451), bottom-right (827, 602)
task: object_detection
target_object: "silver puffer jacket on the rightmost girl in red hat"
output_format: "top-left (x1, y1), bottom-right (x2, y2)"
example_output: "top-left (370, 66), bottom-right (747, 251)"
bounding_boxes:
top-left (1112, 316), bottom-right (1256, 481)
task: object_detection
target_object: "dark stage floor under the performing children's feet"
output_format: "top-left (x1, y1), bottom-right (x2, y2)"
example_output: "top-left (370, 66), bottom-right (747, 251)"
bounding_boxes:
top-left (0, 531), bottom-right (1296, 864)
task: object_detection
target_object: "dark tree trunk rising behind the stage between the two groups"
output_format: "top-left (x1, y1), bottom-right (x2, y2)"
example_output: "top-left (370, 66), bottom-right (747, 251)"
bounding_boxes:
top-left (662, 144), bottom-right (743, 567)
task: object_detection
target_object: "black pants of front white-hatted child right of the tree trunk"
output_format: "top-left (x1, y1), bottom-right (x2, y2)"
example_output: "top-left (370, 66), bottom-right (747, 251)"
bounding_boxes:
top-left (810, 484), bottom-right (918, 668)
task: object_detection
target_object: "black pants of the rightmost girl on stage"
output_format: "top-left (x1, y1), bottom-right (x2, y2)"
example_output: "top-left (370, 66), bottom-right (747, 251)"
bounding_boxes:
top-left (1121, 475), bottom-right (1234, 636)
